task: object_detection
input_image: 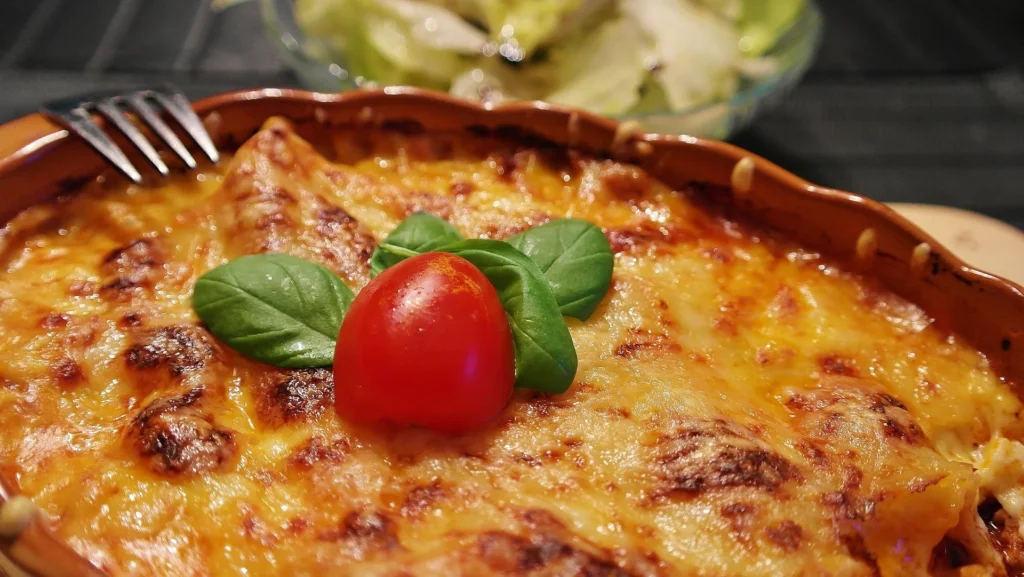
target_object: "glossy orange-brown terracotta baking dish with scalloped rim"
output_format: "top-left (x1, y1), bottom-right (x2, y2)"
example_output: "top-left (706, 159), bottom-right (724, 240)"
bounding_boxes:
top-left (0, 89), bottom-right (1024, 576)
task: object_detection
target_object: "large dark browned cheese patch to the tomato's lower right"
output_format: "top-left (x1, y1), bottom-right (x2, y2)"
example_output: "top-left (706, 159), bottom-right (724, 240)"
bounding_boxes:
top-left (654, 419), bottom-right (801, 497)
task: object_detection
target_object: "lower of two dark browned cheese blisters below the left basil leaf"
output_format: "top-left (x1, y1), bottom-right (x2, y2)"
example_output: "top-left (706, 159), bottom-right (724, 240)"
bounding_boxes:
top-left (128, 389), bottom-right (237, 476)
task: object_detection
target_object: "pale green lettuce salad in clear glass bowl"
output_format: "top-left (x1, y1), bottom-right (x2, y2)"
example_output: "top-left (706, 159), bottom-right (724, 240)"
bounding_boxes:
top-left (262, 0), bottom-right (821, 138)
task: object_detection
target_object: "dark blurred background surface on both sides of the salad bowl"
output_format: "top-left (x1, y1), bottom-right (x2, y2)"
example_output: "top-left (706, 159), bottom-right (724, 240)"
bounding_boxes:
top-left (0, 0), bottom-right (1024, 228)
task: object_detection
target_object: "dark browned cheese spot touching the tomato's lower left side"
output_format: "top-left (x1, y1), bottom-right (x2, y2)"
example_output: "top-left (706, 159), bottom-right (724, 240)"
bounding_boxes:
top-left (256, 369), bottom-right (334, 427)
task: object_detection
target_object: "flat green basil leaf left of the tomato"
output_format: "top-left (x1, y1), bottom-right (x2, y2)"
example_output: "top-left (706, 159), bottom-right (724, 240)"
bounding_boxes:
top-left (193, 254), bottom-right (354, 369)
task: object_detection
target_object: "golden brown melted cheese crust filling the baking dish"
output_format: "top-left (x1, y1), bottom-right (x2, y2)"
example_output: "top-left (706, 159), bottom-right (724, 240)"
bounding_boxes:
top-left (0, 120), bottom-right (1024, 576)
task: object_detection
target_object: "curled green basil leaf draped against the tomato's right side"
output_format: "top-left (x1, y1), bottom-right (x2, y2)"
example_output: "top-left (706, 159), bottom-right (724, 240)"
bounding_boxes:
top-left (439, 239), bottom-right (577, 393)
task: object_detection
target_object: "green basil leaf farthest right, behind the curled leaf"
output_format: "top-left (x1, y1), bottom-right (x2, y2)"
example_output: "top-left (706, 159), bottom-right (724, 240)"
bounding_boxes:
top-left (508, 218), bottom-right (615, 321)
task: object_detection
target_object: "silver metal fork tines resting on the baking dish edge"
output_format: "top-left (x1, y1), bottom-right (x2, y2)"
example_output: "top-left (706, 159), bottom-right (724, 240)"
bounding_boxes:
top-left (40, 84), bottom-right (219, 183)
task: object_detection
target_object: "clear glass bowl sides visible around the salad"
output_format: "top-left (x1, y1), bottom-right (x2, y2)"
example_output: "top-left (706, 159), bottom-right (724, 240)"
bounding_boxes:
top-left (260, 0), bottom-right (824, 140)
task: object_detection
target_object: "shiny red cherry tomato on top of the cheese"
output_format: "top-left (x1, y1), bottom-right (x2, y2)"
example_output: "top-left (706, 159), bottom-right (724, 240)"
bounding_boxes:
top-left (334, 252), bottom-right (515, 432)
